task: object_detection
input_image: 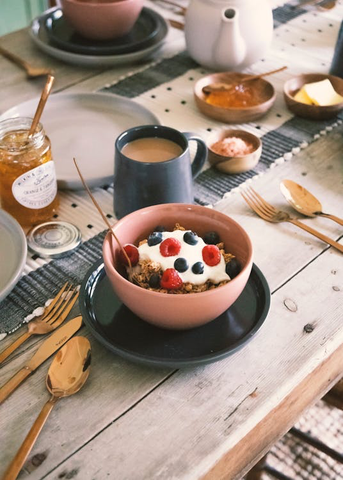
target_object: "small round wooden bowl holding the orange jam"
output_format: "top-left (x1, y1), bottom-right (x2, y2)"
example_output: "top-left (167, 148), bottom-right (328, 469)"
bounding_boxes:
top-left (194, 72), bottom-right (276, 123)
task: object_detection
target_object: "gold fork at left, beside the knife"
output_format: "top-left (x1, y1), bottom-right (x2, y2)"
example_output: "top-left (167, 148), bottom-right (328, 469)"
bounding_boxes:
top-left (0, 282), bottom-right (79, 364)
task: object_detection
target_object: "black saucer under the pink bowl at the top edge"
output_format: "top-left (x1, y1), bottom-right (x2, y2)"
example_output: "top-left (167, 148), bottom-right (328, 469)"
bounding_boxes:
top-left (42, 7), bottom-right (165, 55)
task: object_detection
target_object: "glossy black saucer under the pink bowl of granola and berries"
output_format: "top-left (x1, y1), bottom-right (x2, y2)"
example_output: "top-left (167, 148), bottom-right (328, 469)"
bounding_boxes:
top-left (80, 260), bottom-right (270, 368)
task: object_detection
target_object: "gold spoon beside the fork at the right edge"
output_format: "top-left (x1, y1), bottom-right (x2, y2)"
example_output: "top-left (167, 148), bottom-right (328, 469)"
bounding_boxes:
top-left (280, 180), bottom-right (343, 225)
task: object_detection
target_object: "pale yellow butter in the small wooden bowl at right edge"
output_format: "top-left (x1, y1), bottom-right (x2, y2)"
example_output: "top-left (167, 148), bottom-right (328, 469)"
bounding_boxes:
top-left (294, 78), bottom-right (343, 106)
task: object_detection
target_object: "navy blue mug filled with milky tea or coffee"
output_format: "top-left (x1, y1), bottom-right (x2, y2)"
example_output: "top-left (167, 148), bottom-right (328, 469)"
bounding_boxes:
top-left (114, 125), bottom-right (207, 218)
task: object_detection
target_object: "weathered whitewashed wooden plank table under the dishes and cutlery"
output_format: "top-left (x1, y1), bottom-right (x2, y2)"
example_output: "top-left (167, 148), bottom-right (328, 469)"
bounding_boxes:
top-left (0, 1), bottom-right (343, 480)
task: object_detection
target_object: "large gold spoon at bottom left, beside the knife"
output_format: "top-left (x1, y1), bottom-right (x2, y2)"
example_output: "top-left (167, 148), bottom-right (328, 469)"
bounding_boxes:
top-left (2, 337), bottom-right (91, 480)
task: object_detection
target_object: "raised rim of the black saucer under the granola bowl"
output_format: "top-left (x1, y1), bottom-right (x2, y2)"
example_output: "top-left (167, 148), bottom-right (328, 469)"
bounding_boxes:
top-left (79, 258), bottom-right (271, 368)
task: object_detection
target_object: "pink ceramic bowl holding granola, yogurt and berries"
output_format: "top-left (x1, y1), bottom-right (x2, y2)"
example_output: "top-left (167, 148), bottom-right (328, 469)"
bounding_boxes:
top-left (103, 203), bottom-right (253, 329)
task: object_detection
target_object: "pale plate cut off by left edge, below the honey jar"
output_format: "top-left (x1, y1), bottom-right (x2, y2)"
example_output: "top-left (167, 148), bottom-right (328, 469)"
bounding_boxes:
top-left (0, 209), bottom-right (27, 302)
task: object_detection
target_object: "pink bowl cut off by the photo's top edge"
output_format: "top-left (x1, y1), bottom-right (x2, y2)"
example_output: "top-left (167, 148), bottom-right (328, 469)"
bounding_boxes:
top-left (60, 0), bottom-right (144, 40)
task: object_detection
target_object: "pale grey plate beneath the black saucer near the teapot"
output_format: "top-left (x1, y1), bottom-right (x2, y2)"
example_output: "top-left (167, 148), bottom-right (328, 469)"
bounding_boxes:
top-left (29, 9), bottom-right (168, 67)
